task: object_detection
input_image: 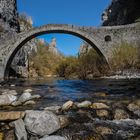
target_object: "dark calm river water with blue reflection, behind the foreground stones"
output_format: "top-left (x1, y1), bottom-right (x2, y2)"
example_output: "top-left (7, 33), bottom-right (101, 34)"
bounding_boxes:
top-left (1, 78), bottom-right (140, 110)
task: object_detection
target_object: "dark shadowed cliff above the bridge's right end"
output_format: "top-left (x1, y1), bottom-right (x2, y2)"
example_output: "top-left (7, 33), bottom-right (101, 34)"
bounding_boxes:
top-left (102, 0), bottom-right (140, 26)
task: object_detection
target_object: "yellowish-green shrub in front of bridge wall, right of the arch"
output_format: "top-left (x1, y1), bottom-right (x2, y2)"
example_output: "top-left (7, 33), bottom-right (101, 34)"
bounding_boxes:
top-left (110, 42), bottom-right (139, 70)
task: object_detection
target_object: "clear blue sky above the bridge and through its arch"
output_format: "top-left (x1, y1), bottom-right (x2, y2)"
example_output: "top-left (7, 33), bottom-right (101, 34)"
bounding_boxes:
top-left (17, 0), bottom-right (111, 55)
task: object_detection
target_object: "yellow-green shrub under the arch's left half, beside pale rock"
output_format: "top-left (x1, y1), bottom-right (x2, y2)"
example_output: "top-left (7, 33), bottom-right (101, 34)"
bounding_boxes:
top-left (29, 44), bottom-right (62, 77)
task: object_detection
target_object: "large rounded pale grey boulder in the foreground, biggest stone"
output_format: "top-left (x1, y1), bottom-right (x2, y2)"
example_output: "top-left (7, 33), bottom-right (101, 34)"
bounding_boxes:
top-left (24, 110), bottom-right (60, 136)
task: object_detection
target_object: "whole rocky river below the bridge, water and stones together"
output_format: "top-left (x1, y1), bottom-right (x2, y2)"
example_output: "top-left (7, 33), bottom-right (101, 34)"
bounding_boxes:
top-left (0, 78), bottom-right (140, 140)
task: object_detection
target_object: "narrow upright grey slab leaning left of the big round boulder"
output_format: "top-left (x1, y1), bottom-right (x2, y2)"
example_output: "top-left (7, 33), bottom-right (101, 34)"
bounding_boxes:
top-left (11, 119), bottom-right (27, 140)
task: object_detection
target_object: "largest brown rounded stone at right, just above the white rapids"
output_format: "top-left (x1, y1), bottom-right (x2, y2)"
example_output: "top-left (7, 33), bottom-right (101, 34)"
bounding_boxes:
top-left (114, 109), bottom-right (129, 120)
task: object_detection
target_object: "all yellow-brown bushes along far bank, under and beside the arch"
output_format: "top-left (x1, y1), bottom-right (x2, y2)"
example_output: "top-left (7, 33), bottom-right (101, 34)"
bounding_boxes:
top-left (30, 42), bottom-right (140, 79)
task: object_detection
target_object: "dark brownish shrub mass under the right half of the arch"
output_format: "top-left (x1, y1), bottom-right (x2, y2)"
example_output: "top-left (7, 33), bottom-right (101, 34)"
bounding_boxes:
top-left (56, 49), bottom-right (105, 79)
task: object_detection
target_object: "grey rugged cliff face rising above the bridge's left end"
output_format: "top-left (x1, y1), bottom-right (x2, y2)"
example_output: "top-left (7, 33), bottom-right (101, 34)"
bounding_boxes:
top-left (0, 0), bottom-right (19, 46)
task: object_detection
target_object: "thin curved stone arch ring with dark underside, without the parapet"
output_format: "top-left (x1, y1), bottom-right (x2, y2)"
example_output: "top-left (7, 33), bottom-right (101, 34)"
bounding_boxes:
top-left (4, 27), bottom-right (108, 79)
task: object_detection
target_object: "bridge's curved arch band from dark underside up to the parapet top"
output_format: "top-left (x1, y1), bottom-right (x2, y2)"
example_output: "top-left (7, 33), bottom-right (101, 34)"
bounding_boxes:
top-left (4, 25), bottom-right (108, 79)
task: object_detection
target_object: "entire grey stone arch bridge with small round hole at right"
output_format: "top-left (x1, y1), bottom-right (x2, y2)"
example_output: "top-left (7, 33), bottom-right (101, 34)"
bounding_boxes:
top-left (0, 23), bottom-right (140, 80)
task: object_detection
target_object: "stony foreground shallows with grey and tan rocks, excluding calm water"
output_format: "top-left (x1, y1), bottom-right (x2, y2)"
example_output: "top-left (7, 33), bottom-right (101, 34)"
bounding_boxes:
top-left (0, 89), bottom-right (140, 140)
